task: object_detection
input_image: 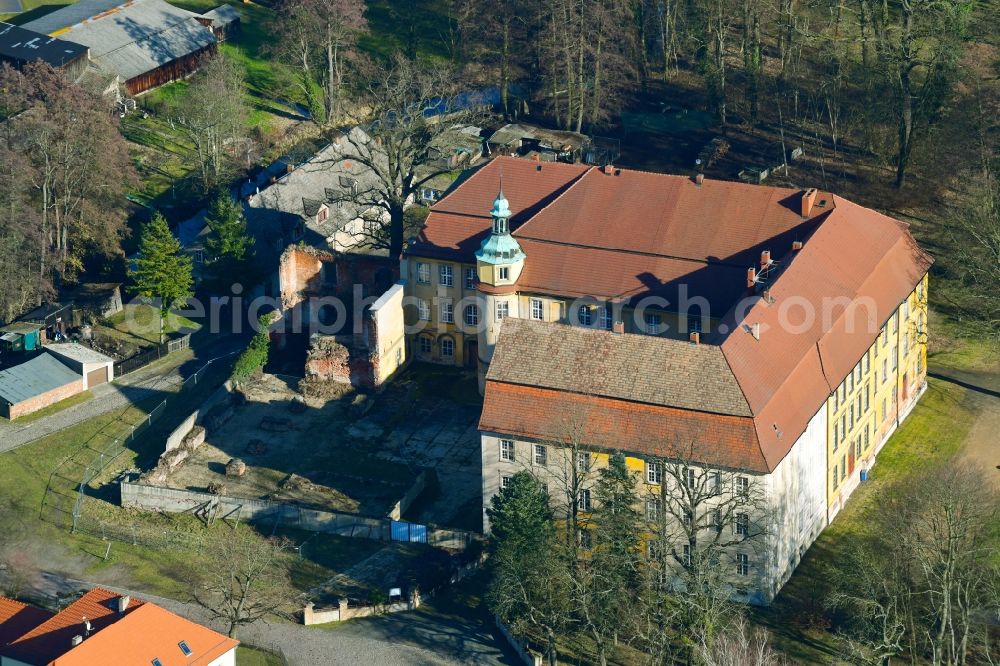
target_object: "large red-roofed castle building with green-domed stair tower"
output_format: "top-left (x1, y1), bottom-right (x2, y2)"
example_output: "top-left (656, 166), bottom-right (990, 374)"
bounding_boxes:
top-left (401, 157), bottom-right (932, 603)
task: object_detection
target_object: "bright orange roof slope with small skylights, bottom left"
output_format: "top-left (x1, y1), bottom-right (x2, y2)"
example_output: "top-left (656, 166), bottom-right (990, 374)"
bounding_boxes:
top-left (53, 604), bottom-right (239, 666)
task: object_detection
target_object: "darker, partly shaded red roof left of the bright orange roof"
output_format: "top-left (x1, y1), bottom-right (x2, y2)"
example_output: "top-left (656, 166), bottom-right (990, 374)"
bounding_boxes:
top-left (2, 587), bottom-right (143, 664)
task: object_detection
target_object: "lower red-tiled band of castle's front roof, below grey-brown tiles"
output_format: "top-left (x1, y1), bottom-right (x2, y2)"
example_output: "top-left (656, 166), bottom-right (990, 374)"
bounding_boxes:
top-left (479, 381), bottom-right (768, 472)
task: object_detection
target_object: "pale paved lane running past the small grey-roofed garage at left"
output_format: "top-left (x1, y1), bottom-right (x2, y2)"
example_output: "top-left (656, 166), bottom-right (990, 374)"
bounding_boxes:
top-left (0, 335), bottom-right (246, 453)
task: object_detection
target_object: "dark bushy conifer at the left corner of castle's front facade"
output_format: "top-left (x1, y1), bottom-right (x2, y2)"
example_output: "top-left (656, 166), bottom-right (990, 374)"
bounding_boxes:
top-left (486, 472), bottom-right (570, 664)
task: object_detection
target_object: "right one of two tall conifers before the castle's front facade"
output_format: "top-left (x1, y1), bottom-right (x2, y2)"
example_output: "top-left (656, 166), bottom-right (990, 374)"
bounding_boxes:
top-left (578, 452), bottom-right (643, 665)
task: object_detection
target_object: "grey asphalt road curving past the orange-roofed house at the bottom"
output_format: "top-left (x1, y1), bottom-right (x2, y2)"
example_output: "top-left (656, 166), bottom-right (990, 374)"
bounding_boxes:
top-left (35, 573), bottom-right (518, 666)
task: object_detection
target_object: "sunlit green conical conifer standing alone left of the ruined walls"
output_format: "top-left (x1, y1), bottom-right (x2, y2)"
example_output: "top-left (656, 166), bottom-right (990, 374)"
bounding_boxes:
top-left (129, 212), bottom-right (193, 344)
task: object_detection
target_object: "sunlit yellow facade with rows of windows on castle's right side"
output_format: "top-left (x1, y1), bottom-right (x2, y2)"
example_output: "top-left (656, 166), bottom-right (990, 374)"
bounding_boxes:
top-left (825, 275), bottom-right (928, 519)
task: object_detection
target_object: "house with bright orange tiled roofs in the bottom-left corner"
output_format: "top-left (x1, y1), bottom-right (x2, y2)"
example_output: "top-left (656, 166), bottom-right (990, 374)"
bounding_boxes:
top-left (0, 588), bottom-right (239, 666)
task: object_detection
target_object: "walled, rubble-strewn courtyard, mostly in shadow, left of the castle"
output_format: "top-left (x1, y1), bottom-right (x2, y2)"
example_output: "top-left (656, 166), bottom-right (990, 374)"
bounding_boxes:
top-left (159, 366), bottom-right (482, 530)
